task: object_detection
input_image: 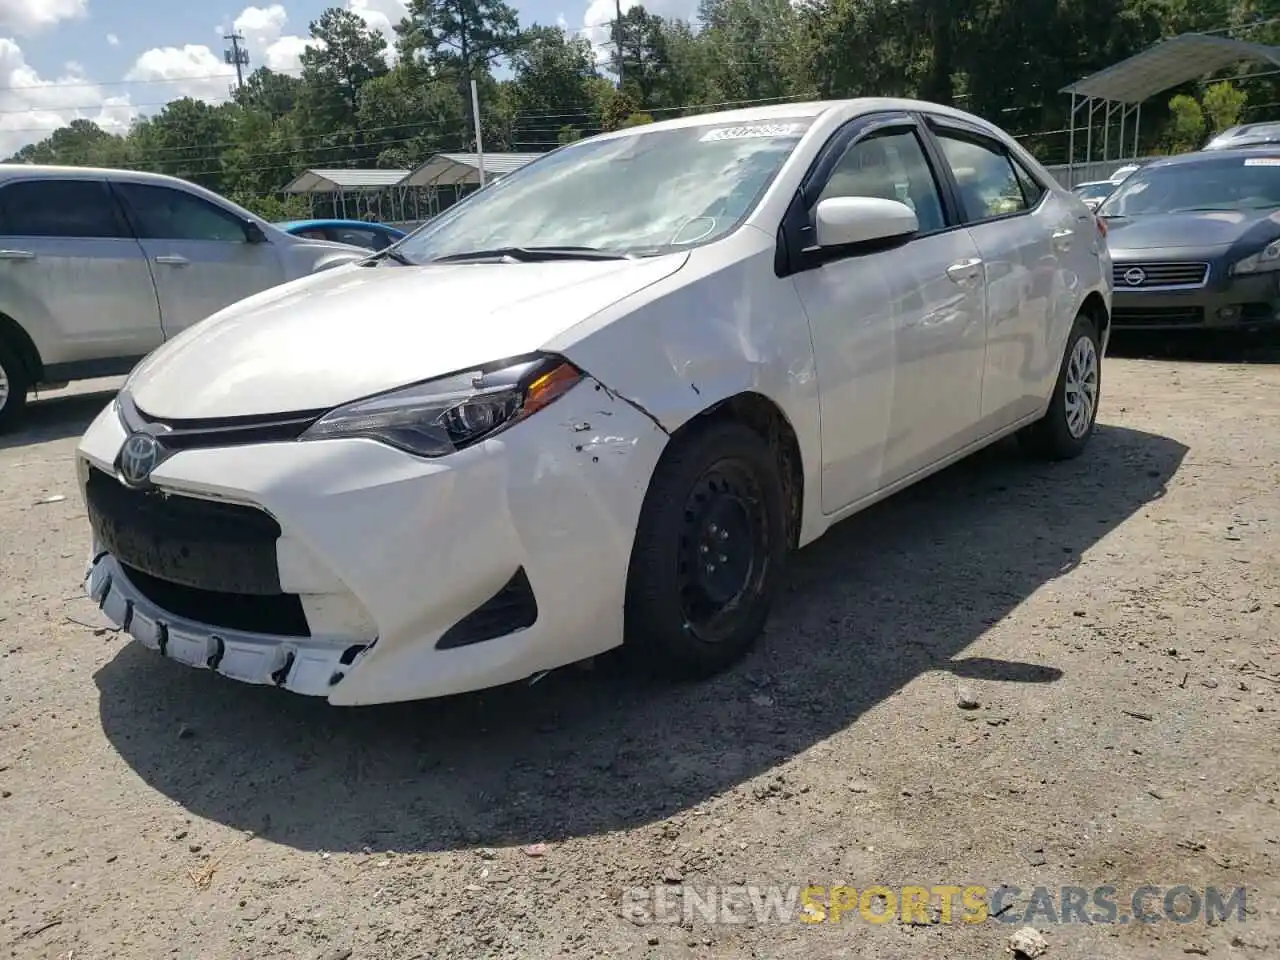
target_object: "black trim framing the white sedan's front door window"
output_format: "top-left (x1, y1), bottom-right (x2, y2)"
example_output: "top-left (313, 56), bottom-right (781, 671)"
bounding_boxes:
top-left (773, 110), bottom-right (966, 278)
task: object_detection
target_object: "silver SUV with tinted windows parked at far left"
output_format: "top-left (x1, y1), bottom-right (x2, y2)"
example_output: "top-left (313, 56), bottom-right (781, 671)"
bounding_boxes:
top-left (0, 164), bottom-right (369, 430)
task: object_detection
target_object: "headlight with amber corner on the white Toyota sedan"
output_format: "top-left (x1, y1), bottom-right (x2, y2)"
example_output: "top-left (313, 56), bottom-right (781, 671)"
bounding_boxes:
top-left (301, 356), bottom-right (582, 457)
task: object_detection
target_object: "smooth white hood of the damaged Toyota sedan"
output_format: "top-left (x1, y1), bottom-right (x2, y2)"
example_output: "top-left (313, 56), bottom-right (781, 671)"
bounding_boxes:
top-left (127, 252), bottom-right (689, 420)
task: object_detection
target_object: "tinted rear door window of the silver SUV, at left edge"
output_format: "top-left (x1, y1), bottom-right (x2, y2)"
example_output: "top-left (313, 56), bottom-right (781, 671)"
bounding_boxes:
top-left (0, 180), bottom-right (125, 237)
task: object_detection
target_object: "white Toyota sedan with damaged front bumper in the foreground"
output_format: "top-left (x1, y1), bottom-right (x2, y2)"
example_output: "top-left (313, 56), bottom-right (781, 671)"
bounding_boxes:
top-left (78, 100), bottom-right (1111, 704)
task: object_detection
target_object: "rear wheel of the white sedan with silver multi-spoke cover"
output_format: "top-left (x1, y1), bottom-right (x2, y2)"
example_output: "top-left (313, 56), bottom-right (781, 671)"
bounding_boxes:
top-left (1018, 312), bottom-right (1102, 460)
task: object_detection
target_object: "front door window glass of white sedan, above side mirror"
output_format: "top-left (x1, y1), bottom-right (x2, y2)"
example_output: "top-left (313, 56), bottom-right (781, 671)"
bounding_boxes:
top-left (818, 131), bottom-right (946, 233)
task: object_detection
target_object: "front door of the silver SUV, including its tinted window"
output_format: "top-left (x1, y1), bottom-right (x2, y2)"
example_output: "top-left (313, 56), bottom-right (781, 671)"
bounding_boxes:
top-left (111, 182), bottom-right (285, 338)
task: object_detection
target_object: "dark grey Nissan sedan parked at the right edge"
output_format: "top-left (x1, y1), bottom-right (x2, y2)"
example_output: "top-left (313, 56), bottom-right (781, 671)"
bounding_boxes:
top-left (1097, 146), bottom-right (1280, 330)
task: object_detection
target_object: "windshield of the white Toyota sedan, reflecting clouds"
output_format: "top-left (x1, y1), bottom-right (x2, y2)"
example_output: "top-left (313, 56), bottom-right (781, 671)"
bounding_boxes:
top-left (399, 118), bottom-right (813, 264)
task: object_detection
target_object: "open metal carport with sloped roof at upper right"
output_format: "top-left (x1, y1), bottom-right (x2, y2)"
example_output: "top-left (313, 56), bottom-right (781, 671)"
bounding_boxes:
top-left (1061, 33), bottom-right (1280, 187)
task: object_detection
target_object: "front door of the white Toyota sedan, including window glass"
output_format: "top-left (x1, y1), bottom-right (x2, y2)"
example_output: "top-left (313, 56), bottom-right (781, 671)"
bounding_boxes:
top-left (792, 123), bottom-right (986, 513)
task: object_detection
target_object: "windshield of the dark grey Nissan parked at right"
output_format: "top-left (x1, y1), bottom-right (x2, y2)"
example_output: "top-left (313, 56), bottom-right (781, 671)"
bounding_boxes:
top-left (1098, 156), bottom-right (1280, 216)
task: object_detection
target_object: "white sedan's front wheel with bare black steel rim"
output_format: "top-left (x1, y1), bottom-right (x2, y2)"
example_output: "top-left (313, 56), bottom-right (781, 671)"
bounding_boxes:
top-left (623, 421), bottom-right (787, 680)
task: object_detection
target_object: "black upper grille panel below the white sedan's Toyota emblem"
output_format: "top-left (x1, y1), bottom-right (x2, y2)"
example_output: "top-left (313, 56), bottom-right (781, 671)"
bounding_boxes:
top-left (86, 467), bottom-right (280, 596)
